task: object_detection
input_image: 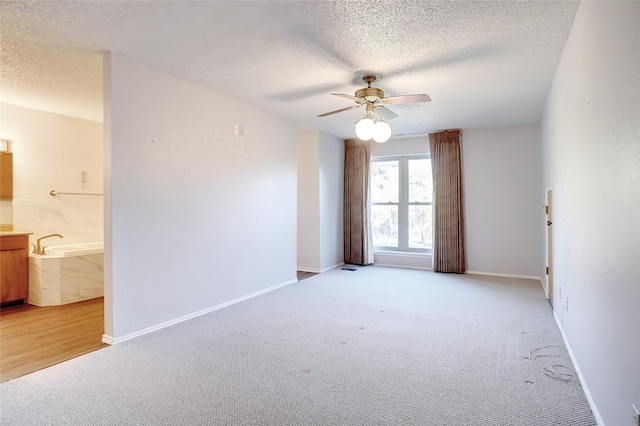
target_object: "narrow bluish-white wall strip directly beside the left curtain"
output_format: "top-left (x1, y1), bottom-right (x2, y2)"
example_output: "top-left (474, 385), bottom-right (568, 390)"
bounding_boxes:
top-left (319, 132), bottom-right (344, 271)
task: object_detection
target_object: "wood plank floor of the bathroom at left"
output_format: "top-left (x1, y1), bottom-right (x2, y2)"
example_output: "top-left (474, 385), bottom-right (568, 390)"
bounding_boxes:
top-left (0, 297), bottom-right (107, 382)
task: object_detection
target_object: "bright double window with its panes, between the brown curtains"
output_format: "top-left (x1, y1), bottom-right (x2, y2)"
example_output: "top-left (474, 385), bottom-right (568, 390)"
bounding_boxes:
top-left (371, 155), bottom-right (433, 252)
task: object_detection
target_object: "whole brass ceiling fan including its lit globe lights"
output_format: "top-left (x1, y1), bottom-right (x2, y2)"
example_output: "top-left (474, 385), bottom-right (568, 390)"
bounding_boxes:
top-left (318, 75), bottom-right (431, 143)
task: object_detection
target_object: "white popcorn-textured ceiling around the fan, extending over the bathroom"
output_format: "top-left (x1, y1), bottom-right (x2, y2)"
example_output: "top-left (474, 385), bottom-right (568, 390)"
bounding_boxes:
top-left (0, 0), bottom-right (578, 138)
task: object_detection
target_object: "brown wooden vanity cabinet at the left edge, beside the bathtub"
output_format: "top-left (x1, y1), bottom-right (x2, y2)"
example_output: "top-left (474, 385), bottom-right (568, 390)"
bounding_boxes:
top-left (0, 235), bottom-right (29, 303)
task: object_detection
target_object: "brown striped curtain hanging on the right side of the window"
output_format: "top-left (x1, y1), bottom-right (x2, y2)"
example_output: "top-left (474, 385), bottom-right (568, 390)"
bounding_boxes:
top-left (429, 130), bottom-right (465, 274)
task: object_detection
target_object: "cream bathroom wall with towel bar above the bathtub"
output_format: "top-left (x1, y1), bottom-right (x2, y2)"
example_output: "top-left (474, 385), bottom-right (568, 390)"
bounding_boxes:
top-left (0, 103), bottom-right (104, 245)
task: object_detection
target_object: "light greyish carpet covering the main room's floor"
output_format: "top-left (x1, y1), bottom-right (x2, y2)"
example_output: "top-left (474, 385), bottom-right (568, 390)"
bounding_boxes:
top-left (0, 266), bottom-right (596, 426)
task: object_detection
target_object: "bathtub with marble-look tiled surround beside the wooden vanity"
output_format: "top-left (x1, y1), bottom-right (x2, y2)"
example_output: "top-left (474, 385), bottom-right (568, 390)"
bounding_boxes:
top-left (29, 241), bottom-right (104, 306)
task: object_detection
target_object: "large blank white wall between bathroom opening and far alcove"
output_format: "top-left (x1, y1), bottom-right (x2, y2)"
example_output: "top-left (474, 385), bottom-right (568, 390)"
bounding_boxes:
top-left (104, 54), bottom-right (296, 342)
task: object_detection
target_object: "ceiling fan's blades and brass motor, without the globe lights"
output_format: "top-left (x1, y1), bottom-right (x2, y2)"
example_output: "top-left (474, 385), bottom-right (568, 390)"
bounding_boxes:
top-left (318, 75), bottom-right (431, 119)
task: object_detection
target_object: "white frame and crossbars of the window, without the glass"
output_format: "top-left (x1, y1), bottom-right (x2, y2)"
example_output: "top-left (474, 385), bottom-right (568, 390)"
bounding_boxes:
top-left (370, 154), bottom-right (433, 253)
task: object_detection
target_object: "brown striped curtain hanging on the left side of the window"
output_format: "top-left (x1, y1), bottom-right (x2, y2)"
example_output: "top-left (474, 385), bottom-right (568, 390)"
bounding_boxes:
top-left (344, 139), bottom-right (373, 265)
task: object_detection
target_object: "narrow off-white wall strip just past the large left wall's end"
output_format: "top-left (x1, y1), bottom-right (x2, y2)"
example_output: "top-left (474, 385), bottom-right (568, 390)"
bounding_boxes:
top-left (297, 130), bottom-right (322, 272)
